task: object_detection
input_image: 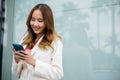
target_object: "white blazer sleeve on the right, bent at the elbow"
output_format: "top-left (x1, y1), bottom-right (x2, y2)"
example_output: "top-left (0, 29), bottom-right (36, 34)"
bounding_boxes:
top-left (34, 40), bottom-right (63, 80)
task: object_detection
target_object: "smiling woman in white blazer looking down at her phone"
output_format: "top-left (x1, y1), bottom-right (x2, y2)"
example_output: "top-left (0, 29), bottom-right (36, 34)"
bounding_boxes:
top-left (12, 4), bottom-right (63, 80)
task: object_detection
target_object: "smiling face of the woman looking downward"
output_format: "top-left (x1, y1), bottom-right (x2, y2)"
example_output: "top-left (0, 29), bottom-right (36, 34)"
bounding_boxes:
top-left (30, 10), bottom-right (45, 35)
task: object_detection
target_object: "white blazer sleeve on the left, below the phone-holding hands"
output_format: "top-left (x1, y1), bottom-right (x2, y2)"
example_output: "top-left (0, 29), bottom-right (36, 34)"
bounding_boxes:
top-left (12, 58), bottom-right (22, 78)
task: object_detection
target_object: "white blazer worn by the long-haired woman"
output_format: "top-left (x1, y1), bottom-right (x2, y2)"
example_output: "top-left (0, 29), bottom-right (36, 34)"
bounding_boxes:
top-left (12, 36), bottom-right (63, 80)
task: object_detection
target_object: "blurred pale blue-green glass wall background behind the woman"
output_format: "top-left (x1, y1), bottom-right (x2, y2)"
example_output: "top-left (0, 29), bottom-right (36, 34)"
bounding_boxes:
top-left (0, 0), bottom-right (120, 80)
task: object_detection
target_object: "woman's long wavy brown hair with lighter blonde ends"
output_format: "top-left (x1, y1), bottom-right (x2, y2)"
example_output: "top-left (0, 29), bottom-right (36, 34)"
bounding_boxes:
top-left (22, 4), bottom-right (61, 50)
